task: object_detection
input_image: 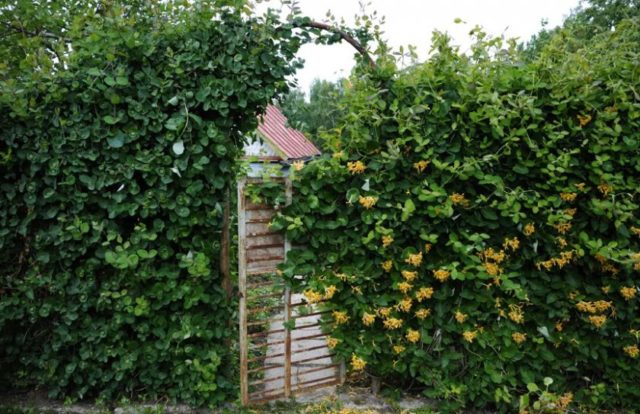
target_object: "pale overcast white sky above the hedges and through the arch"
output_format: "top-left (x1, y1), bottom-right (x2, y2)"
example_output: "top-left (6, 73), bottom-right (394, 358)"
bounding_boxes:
top-left (254, 0), bottom-right (579, 92)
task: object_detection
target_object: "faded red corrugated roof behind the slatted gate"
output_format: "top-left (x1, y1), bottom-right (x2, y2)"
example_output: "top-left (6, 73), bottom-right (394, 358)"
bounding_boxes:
top-left (258, 105), bottom-right (320, 159)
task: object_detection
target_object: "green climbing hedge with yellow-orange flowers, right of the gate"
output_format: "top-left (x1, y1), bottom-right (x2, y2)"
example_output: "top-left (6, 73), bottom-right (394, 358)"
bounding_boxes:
top-left (274, 19), bottom-right (640, 412)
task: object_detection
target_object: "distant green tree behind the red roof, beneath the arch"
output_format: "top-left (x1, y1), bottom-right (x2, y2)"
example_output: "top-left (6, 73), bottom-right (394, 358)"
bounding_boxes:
top-left (280, 79), bottom-right (346, 148)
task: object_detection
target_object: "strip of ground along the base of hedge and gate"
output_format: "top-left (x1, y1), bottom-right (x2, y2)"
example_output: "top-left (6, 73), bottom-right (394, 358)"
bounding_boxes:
top-left (0, 387), bottom-right (437, 414)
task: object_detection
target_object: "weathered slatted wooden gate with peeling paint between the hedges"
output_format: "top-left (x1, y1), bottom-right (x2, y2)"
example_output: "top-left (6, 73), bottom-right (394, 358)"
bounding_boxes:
top-left (238, 177), bottom-right (344, 405)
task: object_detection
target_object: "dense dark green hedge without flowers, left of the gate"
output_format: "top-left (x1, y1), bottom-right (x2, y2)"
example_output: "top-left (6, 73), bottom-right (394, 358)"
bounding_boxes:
top-left (0, 1), bottom-right (302, 404)
